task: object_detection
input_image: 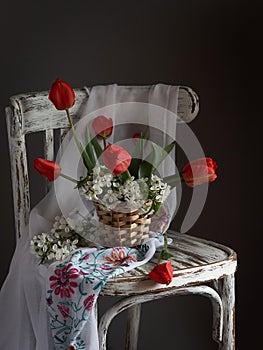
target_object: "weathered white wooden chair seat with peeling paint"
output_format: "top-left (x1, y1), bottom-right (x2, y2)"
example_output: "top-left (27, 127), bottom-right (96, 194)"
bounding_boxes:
top-left (101, 231), bottom-right (237, 296)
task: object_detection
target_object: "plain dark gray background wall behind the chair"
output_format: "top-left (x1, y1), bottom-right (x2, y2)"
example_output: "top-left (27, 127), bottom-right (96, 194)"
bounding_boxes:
top-left (0, 0), bottom-right (262, 350)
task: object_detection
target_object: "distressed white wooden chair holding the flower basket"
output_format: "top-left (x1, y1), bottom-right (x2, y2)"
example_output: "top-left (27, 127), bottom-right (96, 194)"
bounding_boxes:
top-left (6, 86), bottom-right (237, 350)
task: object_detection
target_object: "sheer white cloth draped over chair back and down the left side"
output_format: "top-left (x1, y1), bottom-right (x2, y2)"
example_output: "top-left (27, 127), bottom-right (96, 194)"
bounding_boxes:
top-left (0, 84), bottom-right (179, 350)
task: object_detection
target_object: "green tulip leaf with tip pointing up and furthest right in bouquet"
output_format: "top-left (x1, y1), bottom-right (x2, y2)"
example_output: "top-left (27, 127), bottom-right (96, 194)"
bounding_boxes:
top-left (138, 141), bottom-right (176, 178)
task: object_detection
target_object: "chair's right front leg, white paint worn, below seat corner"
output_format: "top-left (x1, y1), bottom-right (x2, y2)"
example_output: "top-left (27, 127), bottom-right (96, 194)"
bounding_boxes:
top-left (219, 274), bottom-right (235, 350)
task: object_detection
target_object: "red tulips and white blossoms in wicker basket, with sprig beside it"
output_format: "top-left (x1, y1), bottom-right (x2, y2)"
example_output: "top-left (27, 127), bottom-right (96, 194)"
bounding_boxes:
top-left (32, 79), bottom-right (217, 266)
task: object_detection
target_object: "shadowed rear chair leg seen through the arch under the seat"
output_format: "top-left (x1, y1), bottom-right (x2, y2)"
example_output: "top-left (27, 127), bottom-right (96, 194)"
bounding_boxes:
top-left (125, 304), bottom-right (141, 350)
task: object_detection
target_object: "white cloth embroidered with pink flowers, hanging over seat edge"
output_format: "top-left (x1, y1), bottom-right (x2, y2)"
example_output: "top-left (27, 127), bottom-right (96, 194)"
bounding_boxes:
top-left (46, 236), bottom-right (163, 350)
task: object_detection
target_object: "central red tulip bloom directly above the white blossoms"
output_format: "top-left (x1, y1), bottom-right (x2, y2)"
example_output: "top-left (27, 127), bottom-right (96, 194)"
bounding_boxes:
top-left (102, 145), bottom-right (131, 176)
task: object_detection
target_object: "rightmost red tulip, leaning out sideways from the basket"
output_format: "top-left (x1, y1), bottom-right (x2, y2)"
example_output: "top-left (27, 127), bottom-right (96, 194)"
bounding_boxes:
top-left (182, 158), bottom-right (217, 187)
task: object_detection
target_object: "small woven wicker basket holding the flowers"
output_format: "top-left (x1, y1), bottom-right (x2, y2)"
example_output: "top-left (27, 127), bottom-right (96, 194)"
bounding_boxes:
top-left (94, 202), bottom-right (152, 247)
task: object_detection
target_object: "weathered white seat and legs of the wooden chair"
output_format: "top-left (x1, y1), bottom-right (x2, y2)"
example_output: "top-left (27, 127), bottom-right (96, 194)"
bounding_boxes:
top-left (99, 231), bottom-right (237, 350)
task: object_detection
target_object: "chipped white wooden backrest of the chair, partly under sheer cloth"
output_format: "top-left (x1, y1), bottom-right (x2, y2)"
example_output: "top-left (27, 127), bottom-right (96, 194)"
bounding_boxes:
top-left (6, 86), bottom-right (199, 239)
